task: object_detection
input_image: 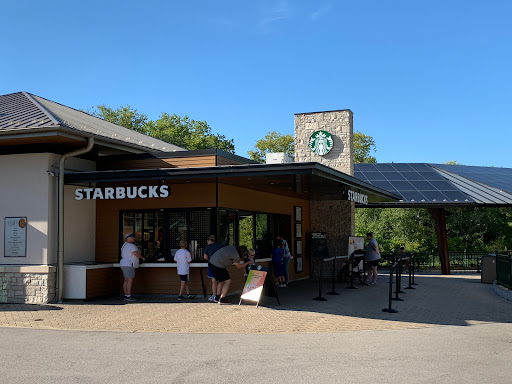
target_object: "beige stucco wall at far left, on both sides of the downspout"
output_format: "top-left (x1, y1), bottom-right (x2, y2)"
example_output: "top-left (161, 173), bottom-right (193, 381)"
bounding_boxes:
top-left (0, 153), bottom-right (96, 265)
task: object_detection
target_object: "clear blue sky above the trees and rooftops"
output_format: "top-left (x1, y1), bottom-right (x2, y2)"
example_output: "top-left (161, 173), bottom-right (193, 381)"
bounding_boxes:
top-left (0, 0), bottom-right (512, 167)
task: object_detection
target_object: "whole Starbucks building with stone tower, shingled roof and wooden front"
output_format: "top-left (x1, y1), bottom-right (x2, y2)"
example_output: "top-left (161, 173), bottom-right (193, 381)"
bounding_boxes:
top-left (0, 92), bottom-right (400, 303)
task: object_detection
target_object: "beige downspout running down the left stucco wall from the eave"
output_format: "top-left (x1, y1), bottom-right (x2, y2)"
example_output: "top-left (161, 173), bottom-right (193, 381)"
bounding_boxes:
top-left (57, 137), bottom-right (94, 303)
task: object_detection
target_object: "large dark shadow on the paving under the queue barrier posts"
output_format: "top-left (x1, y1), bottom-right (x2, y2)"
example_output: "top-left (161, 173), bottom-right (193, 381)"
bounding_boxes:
top-left (260, 273), bottom-right (512, 325)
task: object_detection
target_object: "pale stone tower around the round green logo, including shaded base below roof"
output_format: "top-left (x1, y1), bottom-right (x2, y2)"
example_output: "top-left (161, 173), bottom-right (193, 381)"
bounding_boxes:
top-left (295, 109), bottom-right (355, 256)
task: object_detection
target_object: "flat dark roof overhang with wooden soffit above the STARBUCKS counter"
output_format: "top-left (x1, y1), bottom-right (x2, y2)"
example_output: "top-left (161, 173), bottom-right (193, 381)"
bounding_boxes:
top-left (65, 162), bottom-right (401, 202)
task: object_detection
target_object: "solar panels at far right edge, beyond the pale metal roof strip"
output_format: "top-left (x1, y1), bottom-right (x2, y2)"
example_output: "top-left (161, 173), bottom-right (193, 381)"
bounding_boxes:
top-left (432, 164), bottom-right (512, 193)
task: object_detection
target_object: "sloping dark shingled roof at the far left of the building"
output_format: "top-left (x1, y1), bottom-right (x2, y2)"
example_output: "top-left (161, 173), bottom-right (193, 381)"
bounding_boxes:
top-left (0, 92), bottom-right (186, 152)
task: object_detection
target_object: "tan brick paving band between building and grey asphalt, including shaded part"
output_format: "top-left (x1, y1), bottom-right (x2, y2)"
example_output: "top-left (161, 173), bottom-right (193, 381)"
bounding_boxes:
top-left (0, 274), bottom-right (512, 334)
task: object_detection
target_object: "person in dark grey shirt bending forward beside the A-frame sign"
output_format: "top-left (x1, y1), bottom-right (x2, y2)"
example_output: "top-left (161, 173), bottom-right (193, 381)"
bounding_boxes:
top-left (208, 245), bottom-right (254, 304)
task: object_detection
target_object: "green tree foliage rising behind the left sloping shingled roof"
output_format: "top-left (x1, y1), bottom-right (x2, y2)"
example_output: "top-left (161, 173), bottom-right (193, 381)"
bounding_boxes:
top-left (87, 105), bottom-right (235, 153)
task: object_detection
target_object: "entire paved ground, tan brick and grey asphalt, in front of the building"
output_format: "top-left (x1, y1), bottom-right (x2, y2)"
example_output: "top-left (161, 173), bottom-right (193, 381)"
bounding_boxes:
top-left (0, 274), bottom-right (512, 383)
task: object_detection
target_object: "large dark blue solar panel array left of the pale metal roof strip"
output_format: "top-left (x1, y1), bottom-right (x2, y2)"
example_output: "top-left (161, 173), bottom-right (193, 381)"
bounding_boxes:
top-left (354, 163), bottom-right (474, 204)
